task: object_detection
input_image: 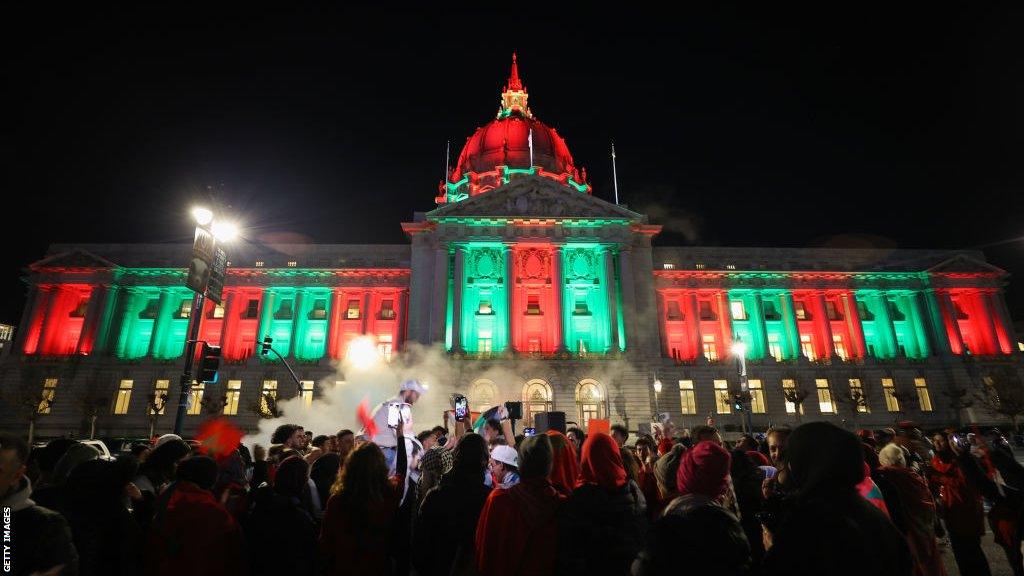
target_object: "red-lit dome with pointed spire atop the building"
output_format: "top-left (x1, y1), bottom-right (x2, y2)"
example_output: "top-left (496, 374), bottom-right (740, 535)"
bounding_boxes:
top-left (436, 54), bottom-right (590, 204)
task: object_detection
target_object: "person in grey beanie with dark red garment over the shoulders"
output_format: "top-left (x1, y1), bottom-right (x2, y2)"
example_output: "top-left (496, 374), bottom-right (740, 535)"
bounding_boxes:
top-left (475, 435), bottom-right (565, 576)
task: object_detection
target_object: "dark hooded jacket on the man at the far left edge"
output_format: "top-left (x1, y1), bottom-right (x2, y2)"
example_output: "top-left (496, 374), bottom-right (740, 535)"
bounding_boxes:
top-left (0, 477), bottom-right (78, 576)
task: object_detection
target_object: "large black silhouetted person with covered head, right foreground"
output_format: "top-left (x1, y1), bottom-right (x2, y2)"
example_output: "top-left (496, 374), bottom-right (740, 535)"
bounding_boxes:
top-left (762, 422), bottom-right (913, 576)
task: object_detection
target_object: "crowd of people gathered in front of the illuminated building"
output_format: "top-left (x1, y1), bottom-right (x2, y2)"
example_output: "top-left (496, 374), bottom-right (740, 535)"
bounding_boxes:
top-left (0, 384), bottom-right (1024, 576)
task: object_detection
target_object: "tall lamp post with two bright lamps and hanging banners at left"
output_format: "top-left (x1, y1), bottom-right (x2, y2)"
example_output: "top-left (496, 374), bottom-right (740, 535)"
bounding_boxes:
top-left (174, 207), bottom-right (238, 436)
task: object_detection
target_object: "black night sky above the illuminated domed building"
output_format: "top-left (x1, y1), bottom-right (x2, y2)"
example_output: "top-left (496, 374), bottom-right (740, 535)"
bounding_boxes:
top-left (0, 2), bottom-right (1024, 324)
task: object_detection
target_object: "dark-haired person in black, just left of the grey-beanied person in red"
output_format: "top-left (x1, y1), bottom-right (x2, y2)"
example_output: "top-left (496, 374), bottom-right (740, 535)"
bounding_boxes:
top-left (413, 434), bottom-right (490, 576)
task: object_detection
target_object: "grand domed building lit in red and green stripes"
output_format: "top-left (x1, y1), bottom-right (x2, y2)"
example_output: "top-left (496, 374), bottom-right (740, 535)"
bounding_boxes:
top-left (0, 57), bottom-right (1021, 436)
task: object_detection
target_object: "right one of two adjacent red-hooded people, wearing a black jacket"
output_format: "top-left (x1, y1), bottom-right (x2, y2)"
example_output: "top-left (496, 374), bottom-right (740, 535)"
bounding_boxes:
top-left (555, 433), bottom-right (647, 576)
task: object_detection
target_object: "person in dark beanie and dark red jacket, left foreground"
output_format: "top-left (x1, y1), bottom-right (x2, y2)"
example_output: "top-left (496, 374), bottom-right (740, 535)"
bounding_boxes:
top-left (143, 456), bottom-right (249, 576)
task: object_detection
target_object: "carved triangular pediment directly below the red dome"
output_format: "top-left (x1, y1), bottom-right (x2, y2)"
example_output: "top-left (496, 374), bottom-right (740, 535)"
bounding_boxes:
top-left (426, 176), bottom-right (646, 222)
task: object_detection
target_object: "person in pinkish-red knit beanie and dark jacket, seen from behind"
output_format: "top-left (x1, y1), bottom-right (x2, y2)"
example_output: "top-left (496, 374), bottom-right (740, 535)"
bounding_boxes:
top-left (632, 441), bottom-right (751, 576)
